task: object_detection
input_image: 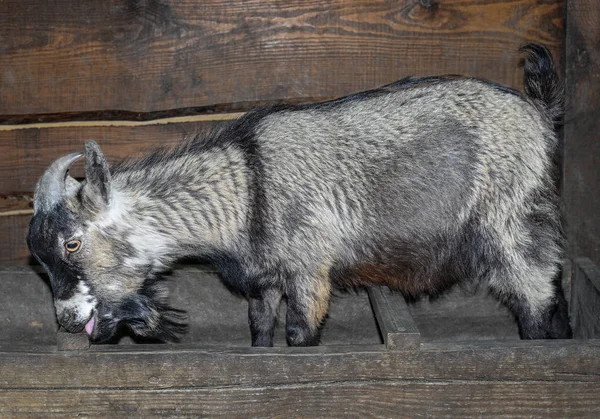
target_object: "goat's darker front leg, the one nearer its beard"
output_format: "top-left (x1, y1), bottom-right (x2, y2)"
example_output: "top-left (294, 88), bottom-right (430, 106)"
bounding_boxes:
top-left (248, 288), bottom-right (283, 346)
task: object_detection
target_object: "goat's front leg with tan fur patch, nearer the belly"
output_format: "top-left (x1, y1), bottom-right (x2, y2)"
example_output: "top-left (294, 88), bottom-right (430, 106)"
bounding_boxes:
top-left (285, 276), bottom-right (331, 346)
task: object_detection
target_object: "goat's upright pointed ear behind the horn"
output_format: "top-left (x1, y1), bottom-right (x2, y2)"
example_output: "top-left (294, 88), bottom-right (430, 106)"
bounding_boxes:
top-left (84, 140), bottom-right (110, 209)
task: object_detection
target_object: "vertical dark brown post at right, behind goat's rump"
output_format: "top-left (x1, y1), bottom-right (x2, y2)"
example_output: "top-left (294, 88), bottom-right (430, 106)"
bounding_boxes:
top-left (563, 0), bottom-right (600, 265)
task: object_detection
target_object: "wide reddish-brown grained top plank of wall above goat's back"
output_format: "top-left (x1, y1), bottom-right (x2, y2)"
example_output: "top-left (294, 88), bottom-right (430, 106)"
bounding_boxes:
top-left (0, 0), bottom-right (563, 115)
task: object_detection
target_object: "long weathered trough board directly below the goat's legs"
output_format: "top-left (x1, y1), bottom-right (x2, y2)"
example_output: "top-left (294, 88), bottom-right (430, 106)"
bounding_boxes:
top-left (0, 340), bottom-right (600, 389)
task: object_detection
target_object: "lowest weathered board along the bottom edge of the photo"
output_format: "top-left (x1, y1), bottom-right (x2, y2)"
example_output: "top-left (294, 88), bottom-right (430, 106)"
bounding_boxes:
top-left (0, 380), bottom-right (600, 418)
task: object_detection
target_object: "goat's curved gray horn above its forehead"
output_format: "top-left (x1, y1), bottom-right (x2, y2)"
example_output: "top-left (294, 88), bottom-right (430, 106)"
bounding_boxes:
top-left (33, 153), bottom-right (83, 213)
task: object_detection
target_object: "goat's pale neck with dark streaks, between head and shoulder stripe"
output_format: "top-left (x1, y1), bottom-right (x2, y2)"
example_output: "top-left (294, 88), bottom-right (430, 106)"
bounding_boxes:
top-left (104, 149), bottom-right (249, 260)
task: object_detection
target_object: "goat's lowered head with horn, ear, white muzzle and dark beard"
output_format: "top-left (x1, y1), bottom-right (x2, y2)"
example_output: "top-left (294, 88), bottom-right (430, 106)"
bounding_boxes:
top-left (27, 141), bottom-right (185, 342)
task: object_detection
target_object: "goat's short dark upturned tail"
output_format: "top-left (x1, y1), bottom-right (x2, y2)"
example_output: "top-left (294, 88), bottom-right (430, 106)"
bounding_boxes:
top-left (521, 44), bottom-right (565, 126)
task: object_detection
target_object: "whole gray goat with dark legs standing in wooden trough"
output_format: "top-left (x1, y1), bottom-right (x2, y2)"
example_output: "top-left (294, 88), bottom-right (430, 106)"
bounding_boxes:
top-left (28, 44), bottom-right (571, 346)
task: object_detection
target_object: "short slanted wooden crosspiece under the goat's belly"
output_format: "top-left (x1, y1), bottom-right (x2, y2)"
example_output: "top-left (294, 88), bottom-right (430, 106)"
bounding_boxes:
top-left (368, 287), bottom-right (421, 350)
